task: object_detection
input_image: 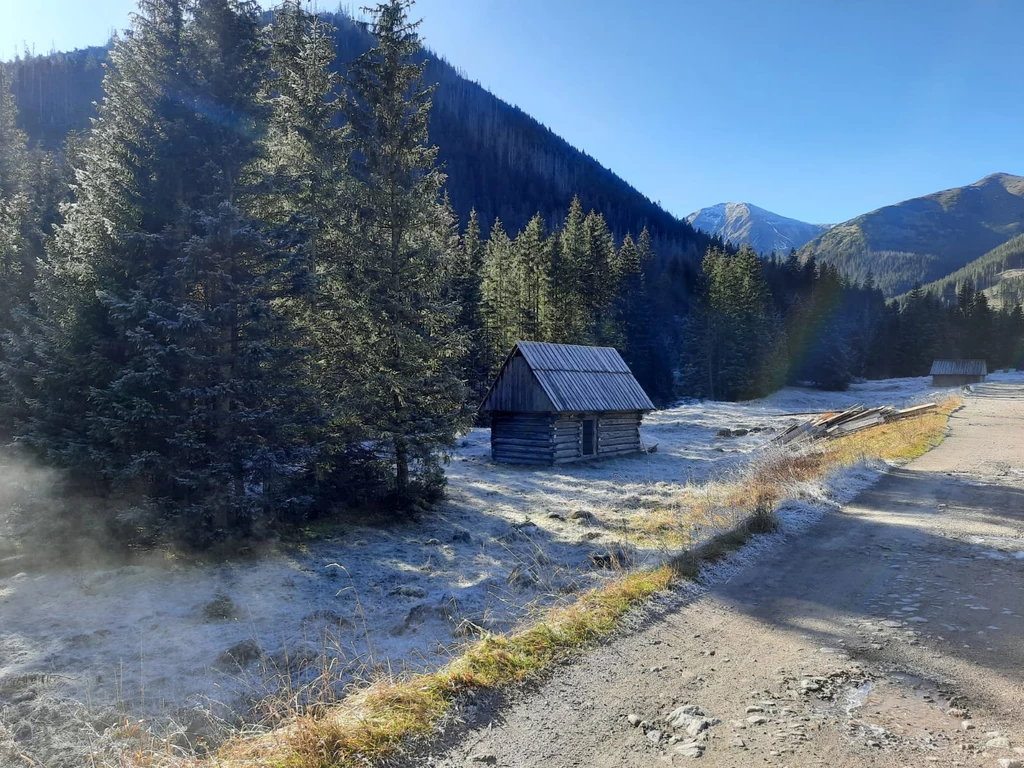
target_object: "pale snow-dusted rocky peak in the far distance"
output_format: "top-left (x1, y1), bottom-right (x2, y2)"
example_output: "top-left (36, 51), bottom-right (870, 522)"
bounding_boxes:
top-left (686, 203), bottom-right (828, 254)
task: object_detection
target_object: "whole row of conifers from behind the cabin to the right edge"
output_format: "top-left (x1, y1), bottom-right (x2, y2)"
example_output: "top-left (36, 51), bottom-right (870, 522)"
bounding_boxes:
top-left (466, 214), bottom-right (1024, 404)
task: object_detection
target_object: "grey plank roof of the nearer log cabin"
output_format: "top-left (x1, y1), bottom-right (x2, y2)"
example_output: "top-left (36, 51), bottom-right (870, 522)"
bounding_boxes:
top-left (480, 341), bottom-right (654, 412)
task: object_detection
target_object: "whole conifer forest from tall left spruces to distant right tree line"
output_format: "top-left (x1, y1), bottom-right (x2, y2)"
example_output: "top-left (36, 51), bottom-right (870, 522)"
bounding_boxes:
top-left (0, 0), bottom-right (1024, 548)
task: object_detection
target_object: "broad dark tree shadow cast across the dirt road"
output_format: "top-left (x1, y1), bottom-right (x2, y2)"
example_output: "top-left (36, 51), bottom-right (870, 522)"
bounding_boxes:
top-left (710, 468), bottom-right (1024, 712)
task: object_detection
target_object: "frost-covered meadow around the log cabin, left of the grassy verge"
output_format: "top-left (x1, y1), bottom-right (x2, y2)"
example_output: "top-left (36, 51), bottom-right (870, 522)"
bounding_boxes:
top-left (0, 372), bottom-right (1011, 766)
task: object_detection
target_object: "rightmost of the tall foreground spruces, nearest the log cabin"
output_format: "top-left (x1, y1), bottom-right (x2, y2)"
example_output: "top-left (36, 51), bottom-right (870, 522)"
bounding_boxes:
top-left (342, 0), bottom-right (468, 505)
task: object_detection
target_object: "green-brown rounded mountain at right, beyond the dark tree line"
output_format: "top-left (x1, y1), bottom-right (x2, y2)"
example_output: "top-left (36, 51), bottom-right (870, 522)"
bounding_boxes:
top-left (800, 173), bottom-right (1024, 296)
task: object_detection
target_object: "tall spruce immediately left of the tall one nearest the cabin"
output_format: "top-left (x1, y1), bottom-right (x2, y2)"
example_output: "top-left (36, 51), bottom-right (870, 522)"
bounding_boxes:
top-left (254, 0), bottom-right (381, 508)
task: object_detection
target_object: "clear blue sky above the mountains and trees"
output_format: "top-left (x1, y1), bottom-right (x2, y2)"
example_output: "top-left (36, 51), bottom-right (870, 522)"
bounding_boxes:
top-left (0, 0), bottom-right (1024, 222)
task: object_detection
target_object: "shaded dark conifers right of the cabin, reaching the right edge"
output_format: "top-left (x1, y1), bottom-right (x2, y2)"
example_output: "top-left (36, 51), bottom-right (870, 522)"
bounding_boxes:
top-left (677, 246), bottom-right (1024, 399)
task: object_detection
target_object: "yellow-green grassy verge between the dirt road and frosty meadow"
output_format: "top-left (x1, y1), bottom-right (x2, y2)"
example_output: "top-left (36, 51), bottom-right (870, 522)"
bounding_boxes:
top-left (142, 399), bottom-right (959, 768)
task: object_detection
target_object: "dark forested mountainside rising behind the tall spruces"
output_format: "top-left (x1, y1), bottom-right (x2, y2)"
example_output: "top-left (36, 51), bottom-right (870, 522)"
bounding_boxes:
top-left (13, 13), bottom-right (711, 262)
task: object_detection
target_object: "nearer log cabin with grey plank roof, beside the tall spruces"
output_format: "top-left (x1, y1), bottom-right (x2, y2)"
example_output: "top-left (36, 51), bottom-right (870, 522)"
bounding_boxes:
top-left (480, 341), bottom-right (654, 464)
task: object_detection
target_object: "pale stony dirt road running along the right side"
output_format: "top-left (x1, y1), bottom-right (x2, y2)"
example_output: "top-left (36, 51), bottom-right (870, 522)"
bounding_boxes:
top-left (416, 385), bottom-right (1024, 768)
